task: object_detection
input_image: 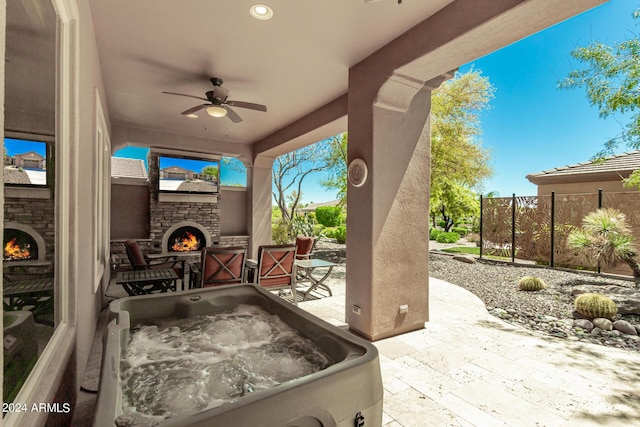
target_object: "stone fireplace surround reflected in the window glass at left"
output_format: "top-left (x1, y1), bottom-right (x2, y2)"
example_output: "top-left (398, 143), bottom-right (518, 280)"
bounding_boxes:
top-left (4, 197), bottom-right (56, 261)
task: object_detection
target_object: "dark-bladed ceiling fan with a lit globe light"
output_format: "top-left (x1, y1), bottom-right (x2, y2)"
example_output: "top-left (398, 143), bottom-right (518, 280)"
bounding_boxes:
top-left (162, 77), bottom-right (267, 123)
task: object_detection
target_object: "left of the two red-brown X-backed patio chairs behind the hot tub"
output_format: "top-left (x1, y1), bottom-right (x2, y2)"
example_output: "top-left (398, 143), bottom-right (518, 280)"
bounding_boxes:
top-left (196, 247), bottom-right (247, 288)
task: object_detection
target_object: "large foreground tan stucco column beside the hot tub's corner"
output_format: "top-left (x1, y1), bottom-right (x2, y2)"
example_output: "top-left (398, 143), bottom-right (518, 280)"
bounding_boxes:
top-left (346, 72), bottom-right (444, 340)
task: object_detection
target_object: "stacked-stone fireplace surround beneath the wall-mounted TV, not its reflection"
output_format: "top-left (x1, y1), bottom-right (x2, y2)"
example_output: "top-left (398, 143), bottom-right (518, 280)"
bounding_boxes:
top-left (148, 152), bottom-right (220, 252)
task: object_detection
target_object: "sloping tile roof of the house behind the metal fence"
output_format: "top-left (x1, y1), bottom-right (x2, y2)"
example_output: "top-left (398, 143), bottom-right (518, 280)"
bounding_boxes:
top-left (527, 150), bottom-right (640, 183)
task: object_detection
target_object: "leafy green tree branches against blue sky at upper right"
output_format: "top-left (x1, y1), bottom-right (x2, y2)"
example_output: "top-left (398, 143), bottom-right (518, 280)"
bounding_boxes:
top-left (558, 9), bottom-right (640, 180)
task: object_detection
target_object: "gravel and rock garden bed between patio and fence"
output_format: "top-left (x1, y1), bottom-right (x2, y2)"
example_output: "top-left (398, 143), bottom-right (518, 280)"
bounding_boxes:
top-left (429, 252), bottom-right (640, 351)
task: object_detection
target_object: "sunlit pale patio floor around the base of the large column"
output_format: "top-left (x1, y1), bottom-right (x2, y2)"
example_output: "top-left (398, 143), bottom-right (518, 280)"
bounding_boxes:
top-left (299, 266), bottom-right (640, 427)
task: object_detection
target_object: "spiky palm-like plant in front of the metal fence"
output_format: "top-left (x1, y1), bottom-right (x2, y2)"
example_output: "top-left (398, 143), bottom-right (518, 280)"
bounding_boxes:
top-left (567, 208), bottom-right (640, 288)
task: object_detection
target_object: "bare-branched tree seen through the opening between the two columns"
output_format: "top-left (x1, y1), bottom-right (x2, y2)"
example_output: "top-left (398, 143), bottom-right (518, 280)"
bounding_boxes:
top-left (272, 143), bottom-right (328, 223)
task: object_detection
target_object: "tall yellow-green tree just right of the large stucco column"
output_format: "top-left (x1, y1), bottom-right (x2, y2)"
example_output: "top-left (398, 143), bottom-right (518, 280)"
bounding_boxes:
top-left (429, 69), bottom-right (495, 231)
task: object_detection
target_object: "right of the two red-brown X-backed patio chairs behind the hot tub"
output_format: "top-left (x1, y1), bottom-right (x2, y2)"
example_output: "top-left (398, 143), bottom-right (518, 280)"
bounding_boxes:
top-left (254, 245), bottom-right (298, 305)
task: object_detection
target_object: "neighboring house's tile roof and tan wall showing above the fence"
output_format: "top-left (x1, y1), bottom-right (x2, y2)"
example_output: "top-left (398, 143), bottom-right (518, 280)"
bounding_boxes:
top-left (527, 150), bottom-right (640, 196)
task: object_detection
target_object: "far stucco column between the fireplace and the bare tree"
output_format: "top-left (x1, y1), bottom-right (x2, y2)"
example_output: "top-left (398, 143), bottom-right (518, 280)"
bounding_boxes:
top-left (247, 156), bottom-right (274, 258)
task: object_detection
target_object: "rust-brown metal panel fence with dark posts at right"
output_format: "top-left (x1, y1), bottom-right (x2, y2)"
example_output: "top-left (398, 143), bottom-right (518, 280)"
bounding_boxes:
top-left (480, 190), bottom-right (640, 275)
